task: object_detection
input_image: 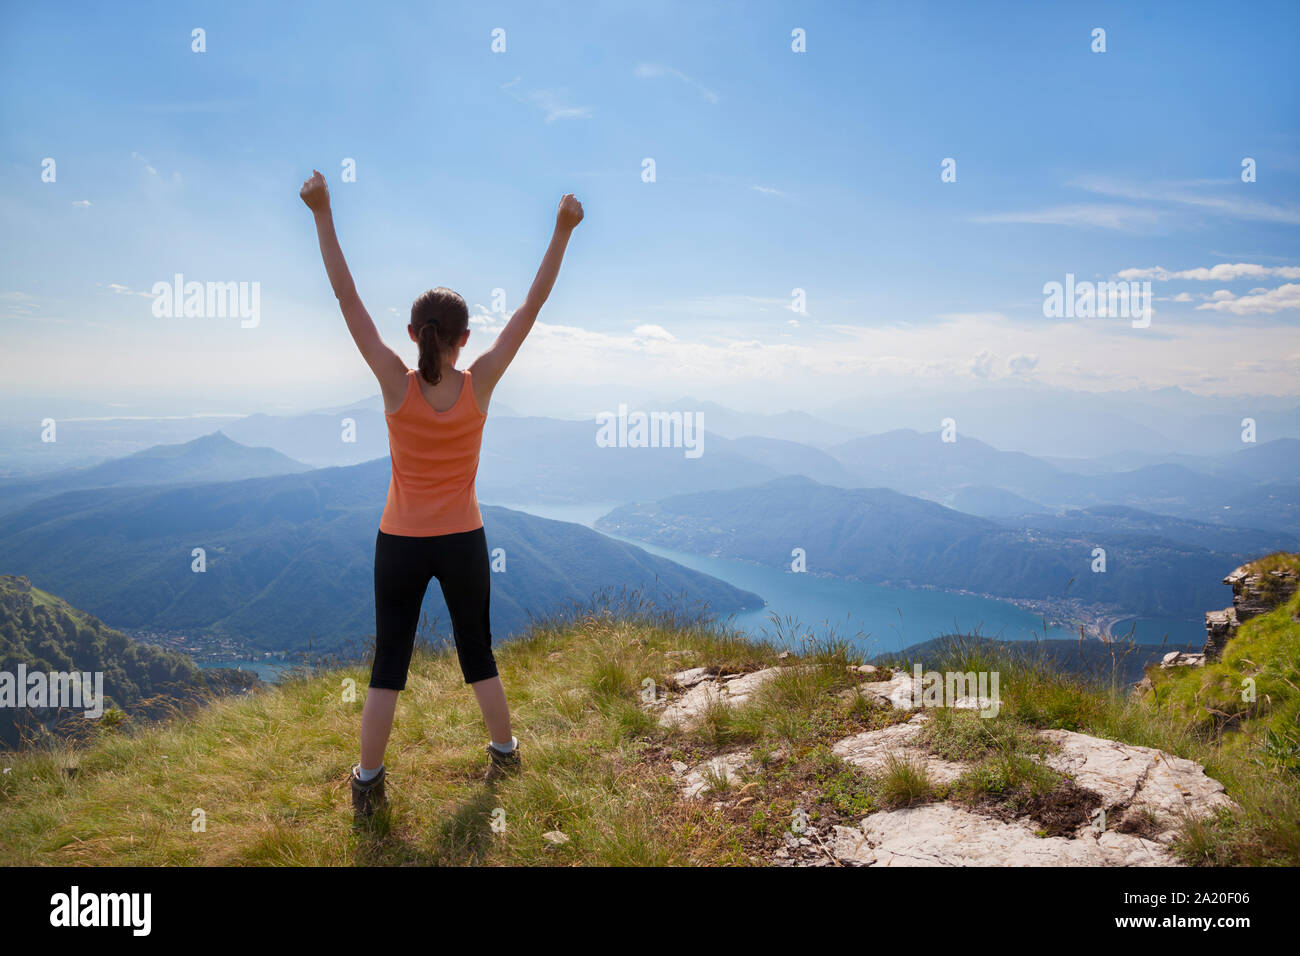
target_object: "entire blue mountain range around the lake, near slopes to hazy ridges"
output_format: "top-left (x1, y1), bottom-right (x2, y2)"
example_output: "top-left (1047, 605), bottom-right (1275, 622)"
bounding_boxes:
top-left (0, 399), bottom-right (1300, 650)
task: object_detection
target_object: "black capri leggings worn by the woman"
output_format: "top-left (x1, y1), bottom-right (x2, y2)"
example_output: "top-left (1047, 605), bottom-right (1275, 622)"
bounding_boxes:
top-left (371, 528), bottom-right (497, 691)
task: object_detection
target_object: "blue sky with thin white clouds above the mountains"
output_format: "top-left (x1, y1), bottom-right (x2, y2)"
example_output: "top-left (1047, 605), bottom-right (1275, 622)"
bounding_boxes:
top-left (0, 3), bottom-right (1300, 412)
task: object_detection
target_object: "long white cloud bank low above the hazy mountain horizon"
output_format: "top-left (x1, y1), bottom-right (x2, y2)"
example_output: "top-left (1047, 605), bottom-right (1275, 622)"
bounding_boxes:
top-left (15, 287), bottom-right (1300, 395)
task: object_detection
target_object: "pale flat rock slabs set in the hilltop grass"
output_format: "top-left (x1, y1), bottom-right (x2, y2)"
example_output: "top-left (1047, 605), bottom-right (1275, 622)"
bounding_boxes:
top-left (653, 656), bottom-right (1234, 866)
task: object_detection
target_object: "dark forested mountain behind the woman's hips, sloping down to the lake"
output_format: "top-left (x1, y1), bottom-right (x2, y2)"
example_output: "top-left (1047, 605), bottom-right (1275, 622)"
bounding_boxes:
top-left (0, 458), bottom-right (762, 650)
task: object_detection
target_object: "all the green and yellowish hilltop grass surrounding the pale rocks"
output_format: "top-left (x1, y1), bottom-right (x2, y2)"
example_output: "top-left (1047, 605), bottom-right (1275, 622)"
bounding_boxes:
top-left (0, 582), bottom-right (1300, 865)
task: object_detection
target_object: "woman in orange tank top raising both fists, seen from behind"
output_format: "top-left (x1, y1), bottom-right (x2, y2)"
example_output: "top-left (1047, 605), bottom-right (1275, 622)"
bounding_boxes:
top-left (299, 170), bottom-right (582, 816)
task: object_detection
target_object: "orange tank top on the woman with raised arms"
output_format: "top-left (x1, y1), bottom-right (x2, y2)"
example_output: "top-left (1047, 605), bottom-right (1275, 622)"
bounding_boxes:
top-left (380, 368), bottom-right (488, 537)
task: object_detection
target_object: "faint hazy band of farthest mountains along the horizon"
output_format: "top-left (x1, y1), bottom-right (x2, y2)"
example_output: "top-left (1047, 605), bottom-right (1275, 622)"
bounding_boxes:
top-left (10, 386), bottom-right (1300, 533)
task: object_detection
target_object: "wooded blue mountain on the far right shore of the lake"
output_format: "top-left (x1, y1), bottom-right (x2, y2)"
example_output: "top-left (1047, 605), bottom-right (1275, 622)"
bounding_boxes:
top-left (595, 477), bottom-right (1268, 618)
